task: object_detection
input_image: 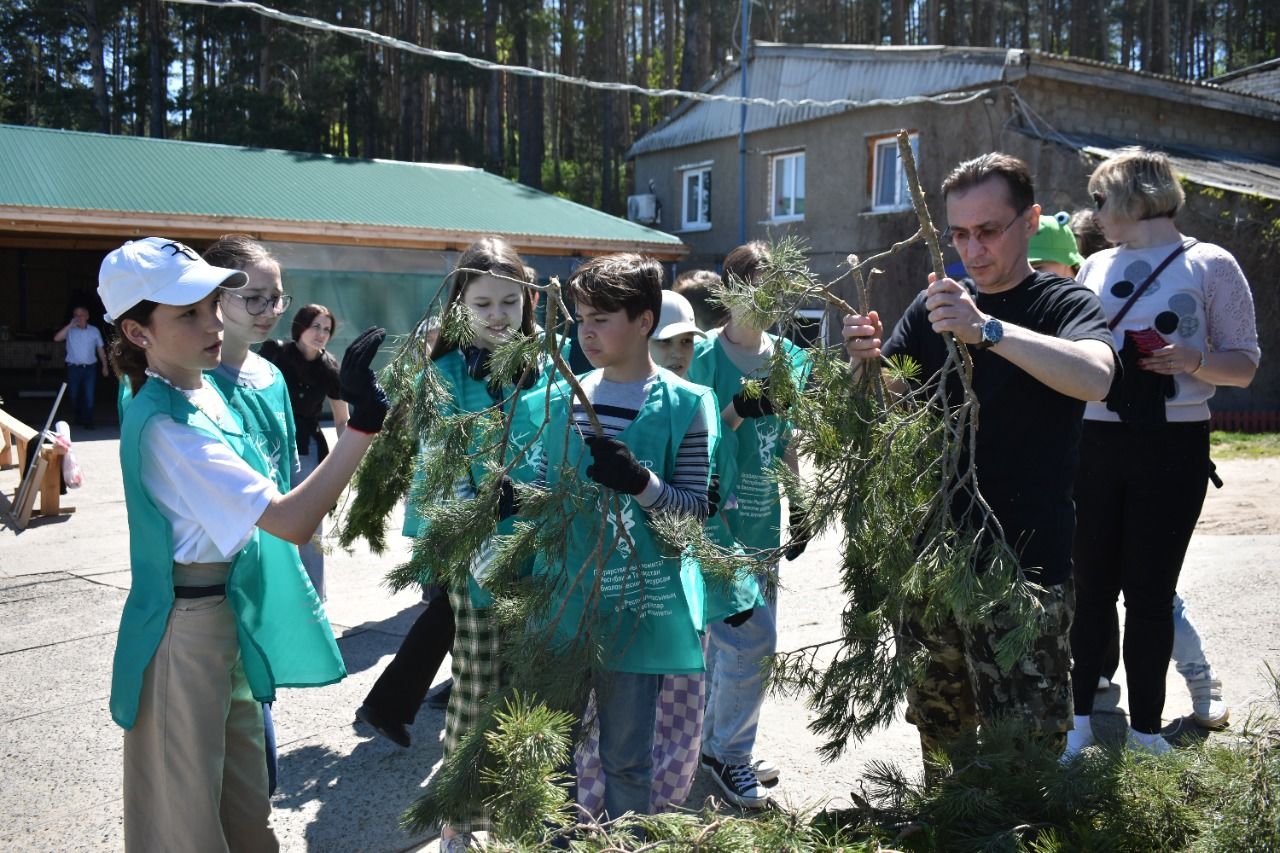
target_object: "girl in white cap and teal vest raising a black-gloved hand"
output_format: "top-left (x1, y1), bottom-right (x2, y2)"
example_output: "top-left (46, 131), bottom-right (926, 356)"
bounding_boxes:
top-left (99, 237), bottom-right (387, 850)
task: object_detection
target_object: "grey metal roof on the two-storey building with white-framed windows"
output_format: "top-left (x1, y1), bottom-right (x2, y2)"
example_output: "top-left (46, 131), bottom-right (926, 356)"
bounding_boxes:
top-left (627, 42), bottom-right (1007, 158)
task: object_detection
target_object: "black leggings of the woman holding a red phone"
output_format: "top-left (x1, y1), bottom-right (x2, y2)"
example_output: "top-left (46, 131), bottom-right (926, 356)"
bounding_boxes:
top-left (1071, 420), bottom-right (1208, 734)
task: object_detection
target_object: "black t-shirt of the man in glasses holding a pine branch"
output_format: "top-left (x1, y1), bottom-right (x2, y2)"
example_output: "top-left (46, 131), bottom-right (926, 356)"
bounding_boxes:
top-left (883, 273), bottom-right (1111, 584)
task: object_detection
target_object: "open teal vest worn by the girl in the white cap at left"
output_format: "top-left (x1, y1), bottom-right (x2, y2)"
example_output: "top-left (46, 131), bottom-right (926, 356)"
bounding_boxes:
top-left (110, 382), bottom-right (347, 729)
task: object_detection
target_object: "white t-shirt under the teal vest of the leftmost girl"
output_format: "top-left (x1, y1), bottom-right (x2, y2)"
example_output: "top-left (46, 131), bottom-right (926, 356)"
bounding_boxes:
top-left (141, 379), bottom-right (279, 562)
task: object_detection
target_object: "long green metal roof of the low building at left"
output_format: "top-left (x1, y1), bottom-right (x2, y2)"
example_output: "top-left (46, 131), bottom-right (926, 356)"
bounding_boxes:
top-left (0, 124), bottom-right (681, 247)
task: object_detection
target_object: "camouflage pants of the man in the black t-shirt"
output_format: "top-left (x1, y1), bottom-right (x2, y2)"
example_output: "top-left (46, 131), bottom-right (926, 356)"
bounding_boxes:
top-left (899, 580), bottom-right (1075, 756)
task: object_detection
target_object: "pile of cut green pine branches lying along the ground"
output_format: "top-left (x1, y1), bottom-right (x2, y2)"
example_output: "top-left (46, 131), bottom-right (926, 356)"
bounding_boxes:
top-left (437, 674), bottom-right (1280, 853)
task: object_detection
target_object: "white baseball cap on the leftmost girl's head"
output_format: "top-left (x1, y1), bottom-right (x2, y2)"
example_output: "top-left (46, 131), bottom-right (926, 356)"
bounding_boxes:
top-left (97, 237), bottom-right (248, 323)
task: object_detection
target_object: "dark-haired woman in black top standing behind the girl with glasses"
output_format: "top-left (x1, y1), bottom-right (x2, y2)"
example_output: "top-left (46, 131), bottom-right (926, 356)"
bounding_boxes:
top-left (259, 305), bottom-right (348, 601)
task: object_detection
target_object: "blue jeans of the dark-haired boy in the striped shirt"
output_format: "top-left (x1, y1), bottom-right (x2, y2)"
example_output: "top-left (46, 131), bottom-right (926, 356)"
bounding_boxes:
top-left (595, 672), bottom-right (662, 820)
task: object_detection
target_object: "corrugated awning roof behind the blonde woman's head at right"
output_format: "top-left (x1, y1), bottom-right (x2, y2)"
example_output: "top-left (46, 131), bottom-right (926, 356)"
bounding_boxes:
top-left (1021, 129), bottom-right (1280, 200)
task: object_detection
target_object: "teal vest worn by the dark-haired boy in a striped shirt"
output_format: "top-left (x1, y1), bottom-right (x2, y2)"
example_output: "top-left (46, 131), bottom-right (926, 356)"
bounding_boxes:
top-left (534, 369), bottom-right (719, 674)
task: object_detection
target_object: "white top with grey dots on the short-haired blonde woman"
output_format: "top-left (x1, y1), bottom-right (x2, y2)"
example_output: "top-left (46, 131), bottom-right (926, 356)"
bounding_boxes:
top-left (1076, 243), bottom-right (1262, 423)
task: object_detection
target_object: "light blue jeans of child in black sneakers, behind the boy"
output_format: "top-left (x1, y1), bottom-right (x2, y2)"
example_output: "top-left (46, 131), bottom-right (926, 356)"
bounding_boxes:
top-left (703, 589), bottom-right (778, 765)
